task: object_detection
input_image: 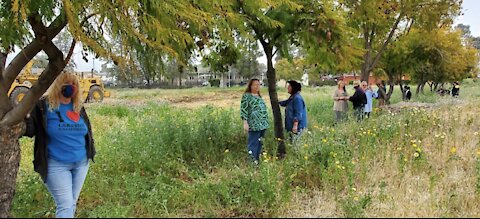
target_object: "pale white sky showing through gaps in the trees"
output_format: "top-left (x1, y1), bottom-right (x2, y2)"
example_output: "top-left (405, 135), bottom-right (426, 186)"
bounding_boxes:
top-left (7, 0), bottom-right (480, 72)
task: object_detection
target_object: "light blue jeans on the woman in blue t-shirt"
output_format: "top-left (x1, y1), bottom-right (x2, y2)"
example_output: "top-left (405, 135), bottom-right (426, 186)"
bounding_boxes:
top-left (46, 159), bottom-right (88, 218)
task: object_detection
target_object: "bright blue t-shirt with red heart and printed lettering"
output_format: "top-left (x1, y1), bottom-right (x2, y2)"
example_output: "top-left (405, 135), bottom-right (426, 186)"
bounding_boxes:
top-left (47, 103), bottom-right (88, 163)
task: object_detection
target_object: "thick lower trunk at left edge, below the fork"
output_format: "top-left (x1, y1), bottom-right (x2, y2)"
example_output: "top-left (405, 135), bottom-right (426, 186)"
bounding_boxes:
top-left (0, 123), bottom-right (25, 218)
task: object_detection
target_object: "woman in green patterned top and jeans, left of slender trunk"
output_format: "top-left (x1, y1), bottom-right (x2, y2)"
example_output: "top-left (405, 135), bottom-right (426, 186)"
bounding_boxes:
top-left (240, 79), bottom-right (269, 164)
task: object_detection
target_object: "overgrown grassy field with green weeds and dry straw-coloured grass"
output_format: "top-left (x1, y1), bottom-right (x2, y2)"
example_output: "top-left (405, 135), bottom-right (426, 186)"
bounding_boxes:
top-left (12, 80), bottom-right (480, 217)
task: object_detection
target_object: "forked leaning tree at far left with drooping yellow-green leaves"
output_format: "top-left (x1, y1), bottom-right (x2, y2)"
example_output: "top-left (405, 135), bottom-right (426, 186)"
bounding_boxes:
top-left (0, 0), bottom-right (222, 218)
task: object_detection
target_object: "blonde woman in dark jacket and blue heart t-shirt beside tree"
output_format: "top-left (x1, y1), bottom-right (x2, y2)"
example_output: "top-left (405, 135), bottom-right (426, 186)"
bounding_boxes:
top-left (25, 73), bottom-right (95, 218)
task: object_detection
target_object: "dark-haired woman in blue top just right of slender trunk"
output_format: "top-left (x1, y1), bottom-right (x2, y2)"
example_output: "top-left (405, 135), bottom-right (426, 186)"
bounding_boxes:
top-left (279, 81), bottom-right (307, 142)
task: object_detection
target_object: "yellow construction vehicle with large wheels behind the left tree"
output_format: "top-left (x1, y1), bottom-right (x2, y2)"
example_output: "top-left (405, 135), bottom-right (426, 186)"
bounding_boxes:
top-left (8, 60), bottom-right (110, 105)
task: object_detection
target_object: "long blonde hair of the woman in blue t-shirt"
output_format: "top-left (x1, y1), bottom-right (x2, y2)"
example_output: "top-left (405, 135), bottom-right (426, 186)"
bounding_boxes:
top-left (47, 73), bottom-right (83, 113)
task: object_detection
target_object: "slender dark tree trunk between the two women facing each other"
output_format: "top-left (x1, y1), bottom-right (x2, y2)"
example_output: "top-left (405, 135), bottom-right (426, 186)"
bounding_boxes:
top-left (264, 45), bottom-right (287, 159)
